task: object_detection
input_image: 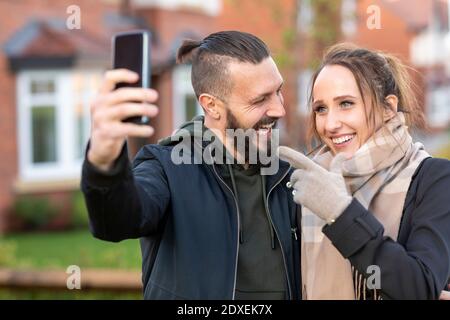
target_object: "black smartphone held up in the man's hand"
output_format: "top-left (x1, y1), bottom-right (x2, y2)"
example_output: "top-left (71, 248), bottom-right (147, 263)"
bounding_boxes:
top-left (112, 30), bottom-right (151, 124)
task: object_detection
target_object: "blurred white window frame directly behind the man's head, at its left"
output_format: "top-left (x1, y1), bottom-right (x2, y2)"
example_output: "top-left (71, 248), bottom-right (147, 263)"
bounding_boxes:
top-left (172, 65), bottom-right (203, 130)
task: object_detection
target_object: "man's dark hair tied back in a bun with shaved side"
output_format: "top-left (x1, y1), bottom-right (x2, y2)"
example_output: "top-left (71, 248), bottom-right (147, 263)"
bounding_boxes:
top-left (177, 31), bottom-right (270, 101)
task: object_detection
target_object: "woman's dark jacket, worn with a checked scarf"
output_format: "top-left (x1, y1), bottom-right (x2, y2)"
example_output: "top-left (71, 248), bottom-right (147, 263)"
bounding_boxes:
top-left (323, 158), bottom-right (450, 300)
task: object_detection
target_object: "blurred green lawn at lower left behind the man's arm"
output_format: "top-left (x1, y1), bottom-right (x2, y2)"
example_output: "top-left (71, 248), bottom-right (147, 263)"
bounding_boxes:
top-left (0, 230), bottom-right (142, 300)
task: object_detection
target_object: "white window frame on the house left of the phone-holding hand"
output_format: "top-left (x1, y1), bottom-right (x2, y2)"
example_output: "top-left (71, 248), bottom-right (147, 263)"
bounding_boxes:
top-left (17, 69), bottom-right (101, 183)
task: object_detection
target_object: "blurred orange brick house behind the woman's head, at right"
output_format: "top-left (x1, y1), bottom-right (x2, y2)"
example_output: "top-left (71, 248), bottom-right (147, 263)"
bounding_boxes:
top-left (350, 0), bottom-right (450, 131)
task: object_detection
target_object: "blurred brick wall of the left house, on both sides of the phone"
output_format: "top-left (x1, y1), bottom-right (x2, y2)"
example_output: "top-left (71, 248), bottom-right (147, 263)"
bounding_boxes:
top-left (0, 0), bottom-right (220, 233)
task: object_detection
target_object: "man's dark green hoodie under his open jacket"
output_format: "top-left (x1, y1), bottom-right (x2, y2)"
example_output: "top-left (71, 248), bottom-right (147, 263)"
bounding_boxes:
top-left (160, 116), bottom-right (287, 300)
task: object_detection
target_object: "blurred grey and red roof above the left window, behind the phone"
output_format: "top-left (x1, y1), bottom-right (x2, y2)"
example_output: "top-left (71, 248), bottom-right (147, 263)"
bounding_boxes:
top-left (3, 14), bottom-right (183, 73)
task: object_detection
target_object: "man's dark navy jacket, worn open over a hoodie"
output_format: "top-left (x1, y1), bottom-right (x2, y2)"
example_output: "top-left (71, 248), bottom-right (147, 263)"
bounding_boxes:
top-left (81, 141), bottom-right (300, 299)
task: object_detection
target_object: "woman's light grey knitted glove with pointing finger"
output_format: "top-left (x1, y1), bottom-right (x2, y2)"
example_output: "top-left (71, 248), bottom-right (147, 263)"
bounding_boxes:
top-left (278, 147), bottom-right (352, 224)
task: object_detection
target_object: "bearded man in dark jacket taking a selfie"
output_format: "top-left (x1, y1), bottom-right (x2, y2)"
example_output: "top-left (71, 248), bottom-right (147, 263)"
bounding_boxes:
top-left (82, 31), bottom-right (300, 299)
